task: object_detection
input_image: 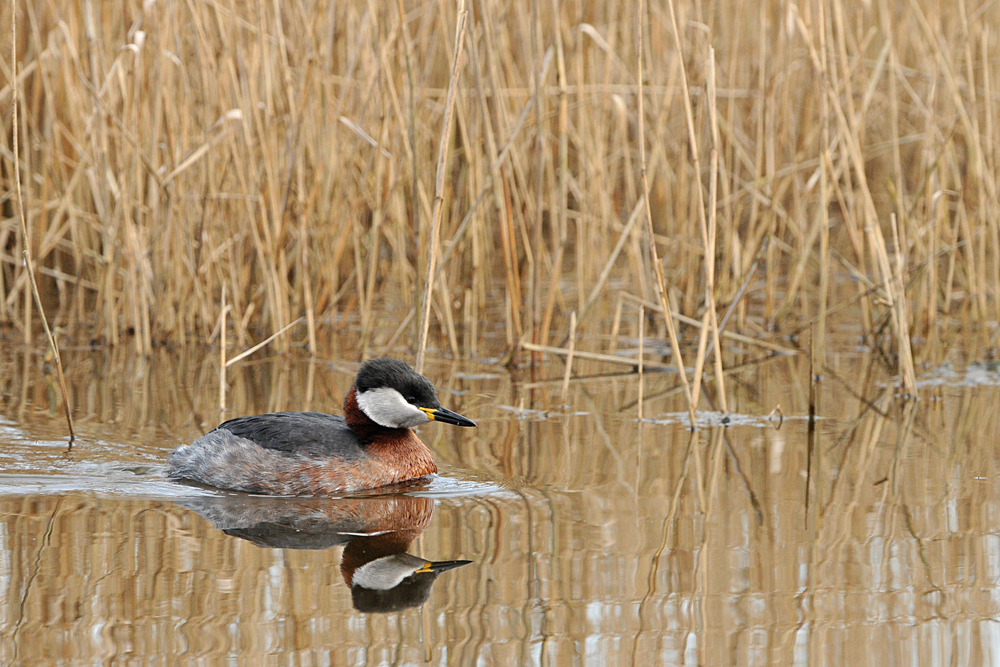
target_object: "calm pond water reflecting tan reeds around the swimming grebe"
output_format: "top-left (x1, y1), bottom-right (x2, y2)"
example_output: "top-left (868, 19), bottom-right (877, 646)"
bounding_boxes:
top-left (0, 344), bottom-right (1000, 665)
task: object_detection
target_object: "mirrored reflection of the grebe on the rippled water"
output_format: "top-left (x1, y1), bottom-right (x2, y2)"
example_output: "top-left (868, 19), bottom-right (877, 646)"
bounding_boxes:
top-left (179, 494), bottom-right (472, 613)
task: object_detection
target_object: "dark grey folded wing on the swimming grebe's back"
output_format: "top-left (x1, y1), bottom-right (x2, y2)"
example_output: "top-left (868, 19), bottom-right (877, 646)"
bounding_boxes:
top-left (215, 412), bottom-right (364, 461)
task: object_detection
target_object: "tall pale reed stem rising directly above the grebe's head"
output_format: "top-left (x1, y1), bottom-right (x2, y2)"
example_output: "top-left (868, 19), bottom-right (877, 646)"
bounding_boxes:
top-left (413, 0), bottom-right (468, 373)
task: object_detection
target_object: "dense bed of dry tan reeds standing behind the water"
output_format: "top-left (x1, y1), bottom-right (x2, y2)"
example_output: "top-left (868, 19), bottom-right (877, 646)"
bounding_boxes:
top-left (0, 0), bottom-right (1000, 396)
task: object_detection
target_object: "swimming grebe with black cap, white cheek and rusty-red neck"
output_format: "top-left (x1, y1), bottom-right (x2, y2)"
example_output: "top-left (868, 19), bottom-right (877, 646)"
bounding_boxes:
top-left (167, 357), bottom-right (476, 496)
